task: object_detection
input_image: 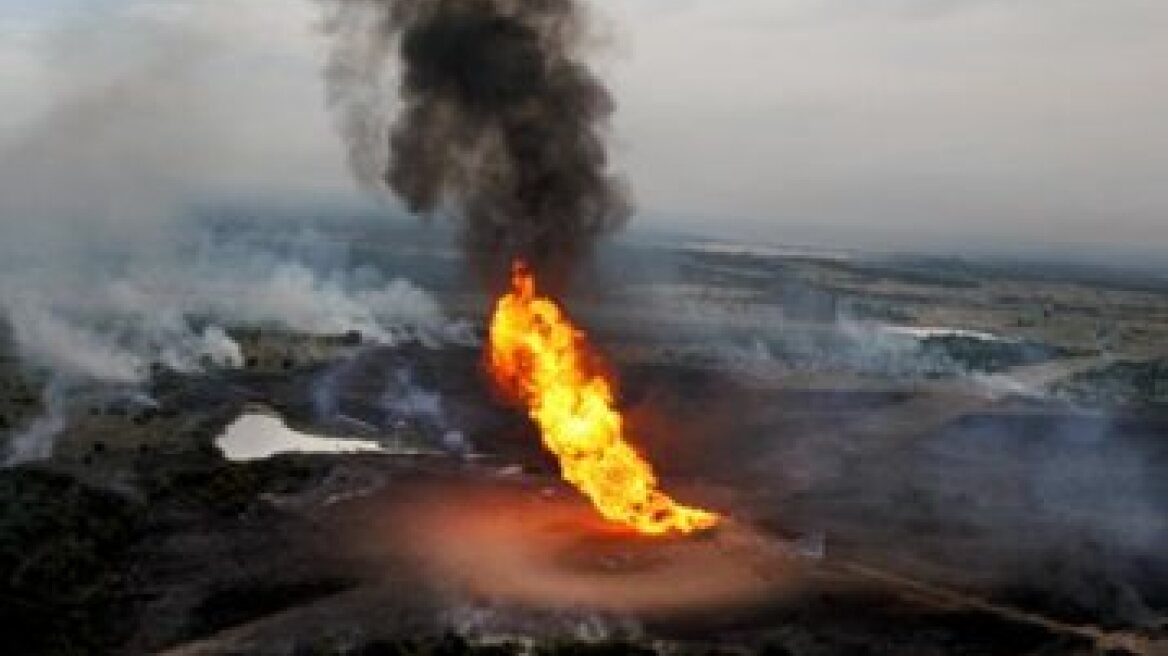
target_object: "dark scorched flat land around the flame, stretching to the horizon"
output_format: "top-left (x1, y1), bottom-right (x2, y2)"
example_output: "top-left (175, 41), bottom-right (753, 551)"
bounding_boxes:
top-left (0, 221), bottom-right (1168, 655)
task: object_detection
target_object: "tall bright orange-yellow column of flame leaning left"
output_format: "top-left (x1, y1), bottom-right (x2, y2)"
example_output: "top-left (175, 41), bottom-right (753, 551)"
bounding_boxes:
top-left (487, 261), bottom-right (718, 535)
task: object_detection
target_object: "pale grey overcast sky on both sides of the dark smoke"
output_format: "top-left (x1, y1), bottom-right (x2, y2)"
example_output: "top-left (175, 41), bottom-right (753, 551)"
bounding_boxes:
top-left (0, 0), bottom-right (1168, 257)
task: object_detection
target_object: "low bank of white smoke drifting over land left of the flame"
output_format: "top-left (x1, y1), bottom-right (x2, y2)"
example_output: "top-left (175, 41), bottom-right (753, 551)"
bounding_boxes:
top-left (0, 248), bottom-right (464, 383)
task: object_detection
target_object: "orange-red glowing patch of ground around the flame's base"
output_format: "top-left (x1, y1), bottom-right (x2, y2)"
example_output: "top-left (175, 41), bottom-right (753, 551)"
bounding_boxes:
top-left (361, 484), bottom-right (808, 614)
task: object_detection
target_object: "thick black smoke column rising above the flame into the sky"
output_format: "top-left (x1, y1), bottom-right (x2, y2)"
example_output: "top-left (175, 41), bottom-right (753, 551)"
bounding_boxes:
top-left (326, 0), bottom-right (631, 284)
